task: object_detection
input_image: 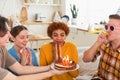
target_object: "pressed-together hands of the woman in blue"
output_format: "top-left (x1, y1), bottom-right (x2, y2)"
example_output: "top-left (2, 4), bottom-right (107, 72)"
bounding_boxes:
top-left (20, 48), bottom-right (32, 65)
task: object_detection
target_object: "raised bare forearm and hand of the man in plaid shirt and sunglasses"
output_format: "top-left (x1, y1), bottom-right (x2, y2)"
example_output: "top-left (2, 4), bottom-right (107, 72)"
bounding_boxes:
top-left (83, 34), bottom-right (107, 62)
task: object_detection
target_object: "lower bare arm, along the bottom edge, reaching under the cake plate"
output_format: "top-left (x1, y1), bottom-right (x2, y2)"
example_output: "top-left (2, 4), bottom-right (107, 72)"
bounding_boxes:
top-left (3, 70), bottom-right (66, 80)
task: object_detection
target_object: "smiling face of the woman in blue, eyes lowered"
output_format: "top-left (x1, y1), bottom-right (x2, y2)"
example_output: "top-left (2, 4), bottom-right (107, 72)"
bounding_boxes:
top-left (13, 30), bottom-right (29, 49)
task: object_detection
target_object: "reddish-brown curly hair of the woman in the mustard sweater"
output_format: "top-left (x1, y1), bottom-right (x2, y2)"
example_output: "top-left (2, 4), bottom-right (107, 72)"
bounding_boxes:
top-left (47, 22), bottom-right (70, 38)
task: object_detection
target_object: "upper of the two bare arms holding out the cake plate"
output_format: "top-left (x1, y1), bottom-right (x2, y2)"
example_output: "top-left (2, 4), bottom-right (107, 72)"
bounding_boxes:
top-left (9, 62), bottom-right (50, 75)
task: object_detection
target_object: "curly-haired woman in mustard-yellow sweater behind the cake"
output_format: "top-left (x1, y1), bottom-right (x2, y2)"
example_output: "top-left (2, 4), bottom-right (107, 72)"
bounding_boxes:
top-left (40, 22), bottom-right (79, 80)
